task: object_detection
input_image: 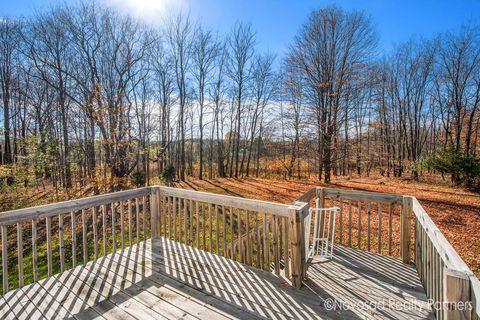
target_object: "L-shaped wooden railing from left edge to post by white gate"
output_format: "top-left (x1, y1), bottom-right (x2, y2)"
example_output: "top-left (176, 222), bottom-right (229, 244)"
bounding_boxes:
top-left (0, 186), bottom-right (308, 294)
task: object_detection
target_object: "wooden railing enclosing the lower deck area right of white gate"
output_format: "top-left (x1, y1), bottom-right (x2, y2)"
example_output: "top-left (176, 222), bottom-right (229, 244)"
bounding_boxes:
top-left (298, 187), bottom-right (480, 319)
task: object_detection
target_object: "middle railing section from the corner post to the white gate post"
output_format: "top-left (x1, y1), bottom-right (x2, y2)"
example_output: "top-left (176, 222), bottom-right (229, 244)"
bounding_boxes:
top-left (152, 187), bottom-right (308, 286)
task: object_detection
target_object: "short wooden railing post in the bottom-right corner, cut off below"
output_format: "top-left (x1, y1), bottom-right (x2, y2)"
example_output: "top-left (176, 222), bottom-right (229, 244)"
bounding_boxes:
top-left (441, 268), bottom-right (472, 320)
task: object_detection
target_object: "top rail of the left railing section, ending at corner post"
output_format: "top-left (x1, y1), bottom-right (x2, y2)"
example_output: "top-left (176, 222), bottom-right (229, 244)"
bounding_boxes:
top-left (0, 187), bottom-right (151, 225)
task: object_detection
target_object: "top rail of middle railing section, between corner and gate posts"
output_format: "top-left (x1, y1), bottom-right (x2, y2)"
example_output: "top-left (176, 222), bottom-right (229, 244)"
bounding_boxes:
top-left (156, 186), bottom-right (290, 217)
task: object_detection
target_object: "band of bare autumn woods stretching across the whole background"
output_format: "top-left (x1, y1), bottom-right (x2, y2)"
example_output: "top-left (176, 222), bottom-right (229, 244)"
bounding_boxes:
top-left (0, 2), bottom-right (480, 198)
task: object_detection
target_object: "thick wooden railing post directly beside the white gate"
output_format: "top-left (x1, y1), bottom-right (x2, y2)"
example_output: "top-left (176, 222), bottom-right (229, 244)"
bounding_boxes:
top-left (288, 203), bottom-right (308, 288)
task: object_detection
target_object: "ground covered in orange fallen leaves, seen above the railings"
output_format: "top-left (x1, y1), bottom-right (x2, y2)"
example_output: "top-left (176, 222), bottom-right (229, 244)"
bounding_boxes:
top-left (177, 178), bottom-right (480, 276)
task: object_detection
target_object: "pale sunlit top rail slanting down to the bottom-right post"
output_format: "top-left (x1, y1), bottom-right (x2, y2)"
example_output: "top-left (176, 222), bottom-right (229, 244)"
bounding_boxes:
top-left (412, 197), bottom-right (473, 276)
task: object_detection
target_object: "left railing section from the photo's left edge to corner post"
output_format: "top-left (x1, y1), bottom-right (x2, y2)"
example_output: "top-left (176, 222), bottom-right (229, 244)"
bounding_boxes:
top-left (0, 187), bottom-right (153, 294)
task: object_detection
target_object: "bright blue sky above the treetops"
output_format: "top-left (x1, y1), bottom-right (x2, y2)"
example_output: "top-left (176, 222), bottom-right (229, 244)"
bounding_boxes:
top-left (0, 0), bottom-right (480, 55)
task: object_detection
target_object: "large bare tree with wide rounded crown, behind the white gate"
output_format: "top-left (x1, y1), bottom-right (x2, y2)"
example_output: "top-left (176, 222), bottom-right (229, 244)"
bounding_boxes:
top-left (293, 7), bottom-right (377, 183)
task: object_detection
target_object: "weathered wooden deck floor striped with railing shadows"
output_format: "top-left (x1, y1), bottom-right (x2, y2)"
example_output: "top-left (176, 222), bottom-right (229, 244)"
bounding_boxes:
top-left (0, 238), bottom-right (433, 320)
